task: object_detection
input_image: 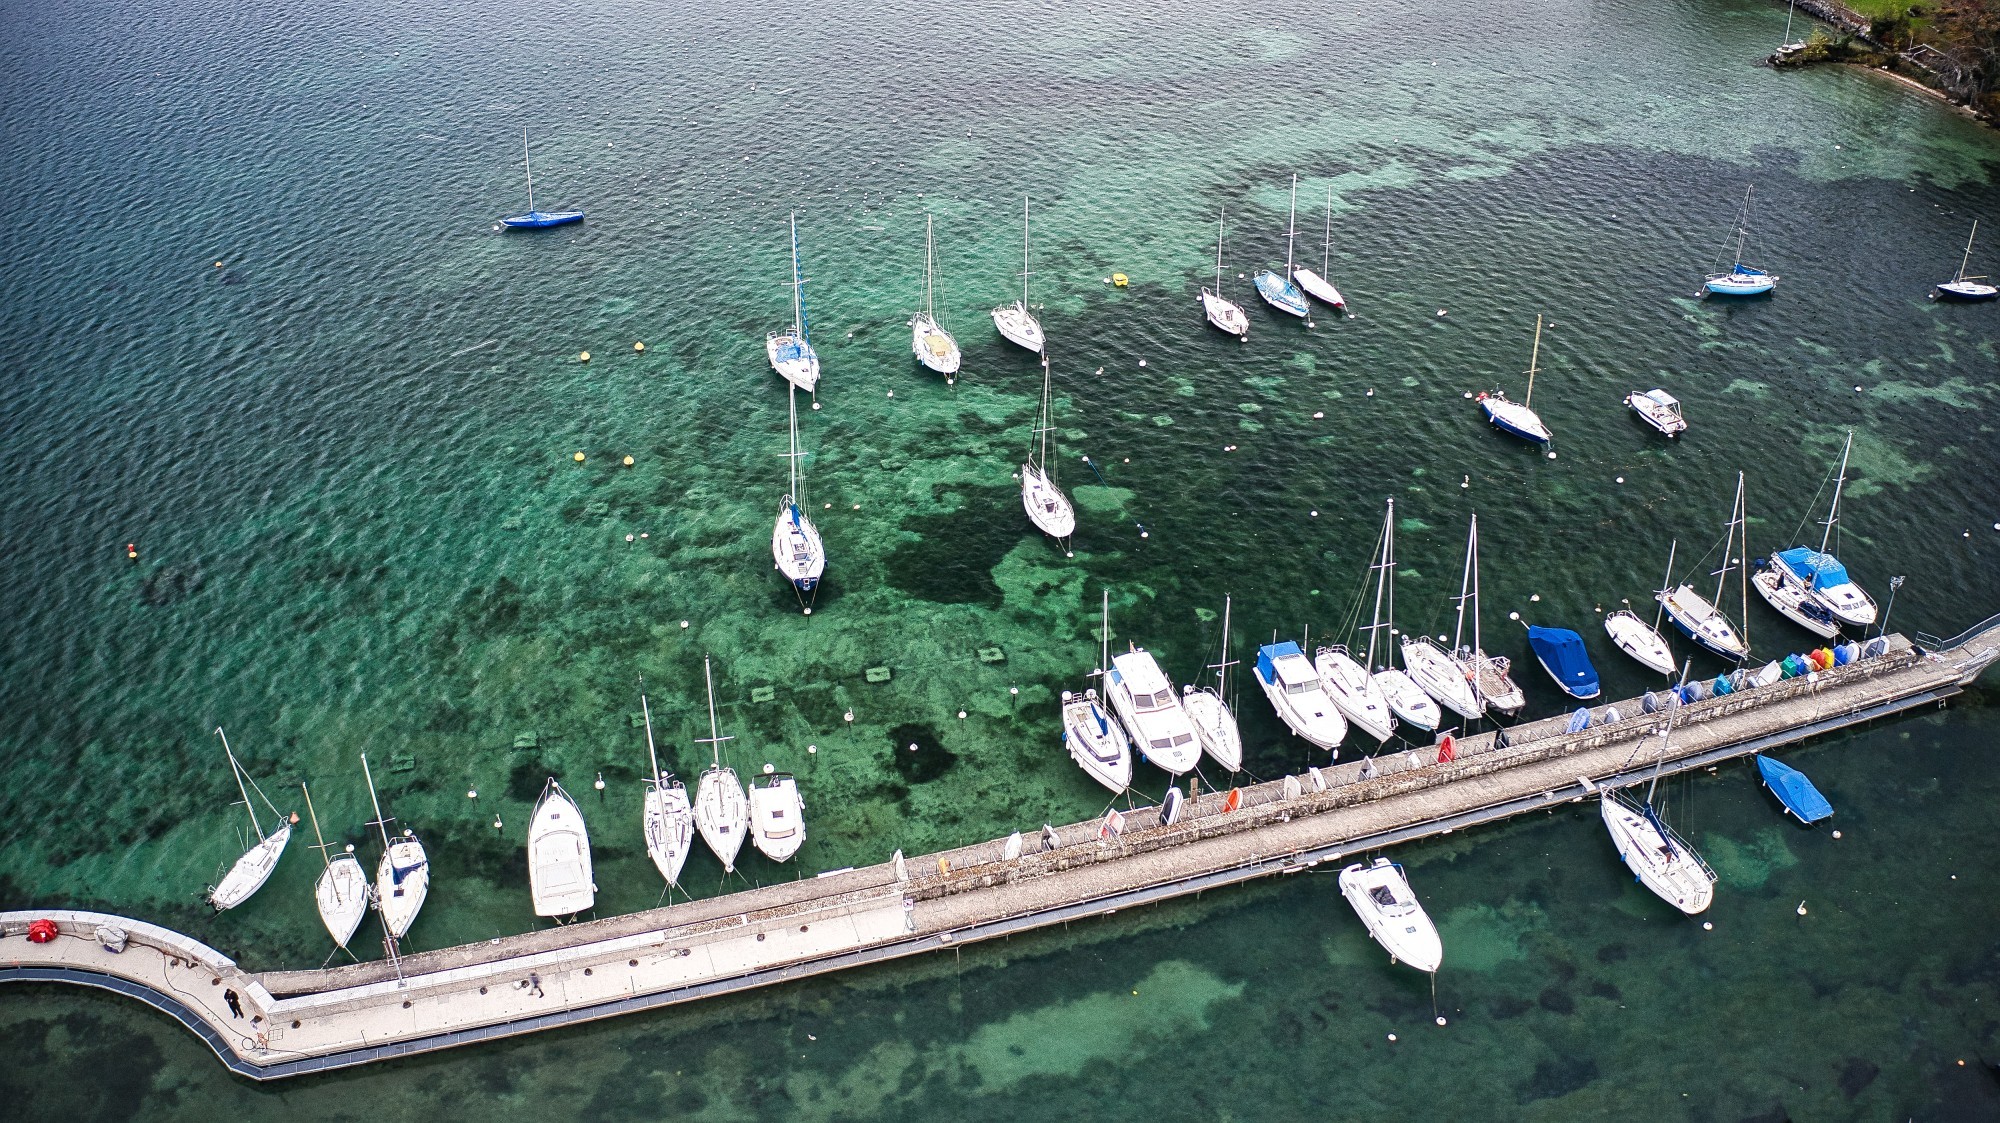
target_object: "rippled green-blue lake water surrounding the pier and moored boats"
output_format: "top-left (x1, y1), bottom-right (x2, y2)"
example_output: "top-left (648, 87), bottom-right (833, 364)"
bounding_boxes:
top-left (0, 2), bottom-right (2000, 1117)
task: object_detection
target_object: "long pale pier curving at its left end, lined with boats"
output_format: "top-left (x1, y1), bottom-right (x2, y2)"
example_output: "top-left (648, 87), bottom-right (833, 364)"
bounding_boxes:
top-left (0, 617), bottom-right (2000, 1079)
